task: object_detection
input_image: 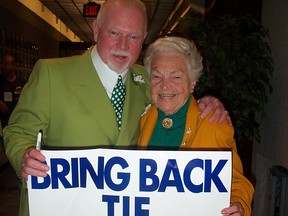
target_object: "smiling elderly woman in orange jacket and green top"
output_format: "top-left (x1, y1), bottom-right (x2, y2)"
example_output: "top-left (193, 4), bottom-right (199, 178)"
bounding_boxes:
top-left (138, 37), bottom-right (254, 216)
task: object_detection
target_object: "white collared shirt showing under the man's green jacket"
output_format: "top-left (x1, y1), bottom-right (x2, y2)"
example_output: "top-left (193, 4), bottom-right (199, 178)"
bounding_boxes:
top-left (91, 46), bottom-right (128, 98)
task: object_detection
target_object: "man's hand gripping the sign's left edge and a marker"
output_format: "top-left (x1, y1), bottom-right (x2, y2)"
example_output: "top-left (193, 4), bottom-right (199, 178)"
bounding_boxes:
top-left (21, 147), bottom-right (50, 180)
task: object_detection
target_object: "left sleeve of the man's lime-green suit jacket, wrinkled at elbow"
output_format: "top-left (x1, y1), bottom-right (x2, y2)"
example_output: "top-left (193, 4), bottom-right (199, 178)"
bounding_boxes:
top-left (3, 58), bottom-right (50, 175)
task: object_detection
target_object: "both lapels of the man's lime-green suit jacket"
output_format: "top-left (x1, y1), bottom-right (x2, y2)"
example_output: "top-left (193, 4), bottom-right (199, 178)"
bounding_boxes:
top-left (71, 51), bottom-right (150, 146)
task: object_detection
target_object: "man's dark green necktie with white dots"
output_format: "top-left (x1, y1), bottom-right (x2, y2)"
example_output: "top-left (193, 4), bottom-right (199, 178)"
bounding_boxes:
top-left (111, 75), bottom-right (126, 130)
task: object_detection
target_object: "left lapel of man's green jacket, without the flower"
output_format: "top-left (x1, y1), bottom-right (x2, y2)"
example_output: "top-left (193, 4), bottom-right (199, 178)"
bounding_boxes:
top-left (72, 51), bottom-right (119, 144)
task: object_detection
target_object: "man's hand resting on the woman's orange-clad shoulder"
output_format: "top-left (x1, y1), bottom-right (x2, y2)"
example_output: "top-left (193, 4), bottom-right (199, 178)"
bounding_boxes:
top-left (198, 96), bottom-right (232, 126)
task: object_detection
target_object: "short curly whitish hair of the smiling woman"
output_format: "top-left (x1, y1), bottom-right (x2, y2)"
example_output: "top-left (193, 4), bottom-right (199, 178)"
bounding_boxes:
top-left (144, 37), bottom-right (203, 81)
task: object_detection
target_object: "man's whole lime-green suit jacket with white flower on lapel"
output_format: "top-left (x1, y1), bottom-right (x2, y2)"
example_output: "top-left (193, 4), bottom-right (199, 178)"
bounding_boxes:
top-left (4, 47), bottom-right (150, 215)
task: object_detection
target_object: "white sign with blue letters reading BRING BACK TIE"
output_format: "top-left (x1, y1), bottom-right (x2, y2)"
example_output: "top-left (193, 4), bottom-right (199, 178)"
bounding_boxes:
top-left (28, 149), bottom-right (232, 216)
